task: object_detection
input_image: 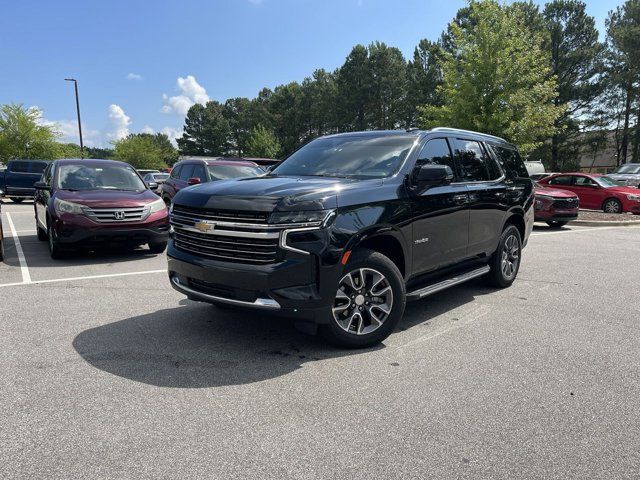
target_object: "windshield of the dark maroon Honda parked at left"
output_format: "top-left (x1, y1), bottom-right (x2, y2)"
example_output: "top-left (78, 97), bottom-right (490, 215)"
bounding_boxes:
top-left (58, 164), bottom-right (146, 192)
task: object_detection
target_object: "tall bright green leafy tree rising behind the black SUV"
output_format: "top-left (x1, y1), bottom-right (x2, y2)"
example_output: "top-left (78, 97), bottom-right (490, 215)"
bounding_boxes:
top-left (420, 0), bottom-right (564, 154)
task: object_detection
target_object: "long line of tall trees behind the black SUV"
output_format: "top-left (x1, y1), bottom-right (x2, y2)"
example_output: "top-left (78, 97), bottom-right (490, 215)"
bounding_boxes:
top-left (178, 0), bottom-right (640, 170)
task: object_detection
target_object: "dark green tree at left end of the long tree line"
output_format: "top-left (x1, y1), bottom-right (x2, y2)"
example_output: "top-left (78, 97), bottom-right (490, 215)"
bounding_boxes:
top-left (177, 101), bottom-right (231, 157)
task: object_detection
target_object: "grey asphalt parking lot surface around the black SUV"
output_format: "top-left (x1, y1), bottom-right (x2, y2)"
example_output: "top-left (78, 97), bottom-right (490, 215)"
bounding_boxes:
top-left (0, 202), bottom-right (640, 479)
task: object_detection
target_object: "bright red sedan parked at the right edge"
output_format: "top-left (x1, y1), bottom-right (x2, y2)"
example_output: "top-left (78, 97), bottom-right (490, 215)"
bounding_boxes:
top-left (539, 173), bottom-right (640, 214)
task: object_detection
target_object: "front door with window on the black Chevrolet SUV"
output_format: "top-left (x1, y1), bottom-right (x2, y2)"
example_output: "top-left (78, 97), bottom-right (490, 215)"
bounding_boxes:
top-left (411, 138), bottom-right (469, 274)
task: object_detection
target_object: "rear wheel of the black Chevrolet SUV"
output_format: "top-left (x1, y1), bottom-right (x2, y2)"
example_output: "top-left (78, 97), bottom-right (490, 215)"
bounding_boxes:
top-left (485, 224), bottom-right (522, 288)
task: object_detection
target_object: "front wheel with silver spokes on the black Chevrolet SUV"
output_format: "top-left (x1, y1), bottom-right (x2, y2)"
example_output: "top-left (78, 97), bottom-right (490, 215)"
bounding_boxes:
top-left (320, 249), bottom-right (406, 348)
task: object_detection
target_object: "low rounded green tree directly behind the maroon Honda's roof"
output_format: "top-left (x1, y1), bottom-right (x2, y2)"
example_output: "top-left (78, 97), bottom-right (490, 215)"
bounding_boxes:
top-left (112, 133), bottom-right (176, 169)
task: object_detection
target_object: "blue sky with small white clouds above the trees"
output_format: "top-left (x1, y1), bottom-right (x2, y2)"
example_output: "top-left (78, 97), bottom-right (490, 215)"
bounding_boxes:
top-left (0, 0), bottom-right (622, 146)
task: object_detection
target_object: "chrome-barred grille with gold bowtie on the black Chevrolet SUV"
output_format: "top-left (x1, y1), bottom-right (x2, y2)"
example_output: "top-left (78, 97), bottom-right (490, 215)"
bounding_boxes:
top-left (171, 205), bottom-right (281, 264)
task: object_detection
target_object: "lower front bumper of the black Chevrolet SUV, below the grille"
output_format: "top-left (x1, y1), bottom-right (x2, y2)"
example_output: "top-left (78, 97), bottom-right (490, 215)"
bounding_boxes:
top-left (167, 239), bottom-right (339, 323)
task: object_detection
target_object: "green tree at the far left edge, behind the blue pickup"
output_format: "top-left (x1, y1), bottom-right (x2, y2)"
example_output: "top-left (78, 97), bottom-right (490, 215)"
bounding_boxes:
top-left (0, 104), bottom-right (59, 162)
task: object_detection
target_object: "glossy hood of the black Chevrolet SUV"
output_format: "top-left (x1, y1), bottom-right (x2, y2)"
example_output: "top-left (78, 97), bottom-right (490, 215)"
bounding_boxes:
top-left (173, 172), bottom-right (382, 212)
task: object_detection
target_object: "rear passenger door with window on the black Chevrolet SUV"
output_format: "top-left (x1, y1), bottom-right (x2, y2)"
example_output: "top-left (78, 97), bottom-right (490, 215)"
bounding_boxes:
top-left (454, 137), bottom-right (508, 257)
